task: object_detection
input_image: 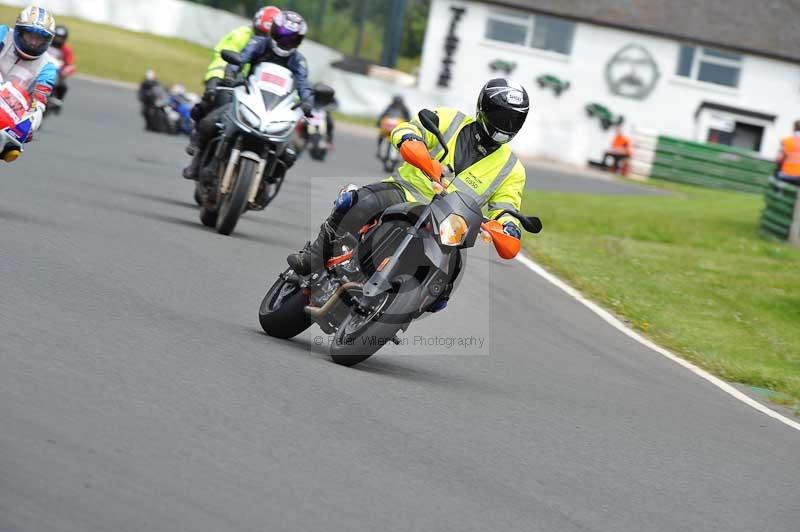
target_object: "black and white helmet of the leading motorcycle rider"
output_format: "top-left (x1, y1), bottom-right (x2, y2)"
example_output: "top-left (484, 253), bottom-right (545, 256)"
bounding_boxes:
top-left (477, 78), bottom-right (530, 144)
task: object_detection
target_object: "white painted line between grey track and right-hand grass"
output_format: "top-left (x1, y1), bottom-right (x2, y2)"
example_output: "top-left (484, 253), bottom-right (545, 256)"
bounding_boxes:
top-left (517, 250), bottom-right (800, 431)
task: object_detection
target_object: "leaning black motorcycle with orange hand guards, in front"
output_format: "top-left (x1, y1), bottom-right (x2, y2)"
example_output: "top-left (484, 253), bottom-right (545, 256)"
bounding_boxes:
top-left (259, 110), bottom-right (542, 366)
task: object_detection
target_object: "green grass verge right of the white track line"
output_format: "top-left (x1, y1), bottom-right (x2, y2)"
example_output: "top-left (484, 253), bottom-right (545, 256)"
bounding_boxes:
top-left (525, 181), bottom-right (800, 410)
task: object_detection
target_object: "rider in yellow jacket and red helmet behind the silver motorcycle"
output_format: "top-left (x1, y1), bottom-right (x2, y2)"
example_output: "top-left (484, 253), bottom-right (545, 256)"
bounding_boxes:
top-left (192, 6), bottom-right (281, 122)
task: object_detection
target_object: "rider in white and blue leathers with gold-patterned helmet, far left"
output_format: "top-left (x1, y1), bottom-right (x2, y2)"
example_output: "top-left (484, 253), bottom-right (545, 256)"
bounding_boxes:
top-left (0, 7), bottom-right (58, 135)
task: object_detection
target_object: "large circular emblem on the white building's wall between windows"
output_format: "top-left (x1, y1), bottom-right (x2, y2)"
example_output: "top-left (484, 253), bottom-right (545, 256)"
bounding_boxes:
top-left (606, 44), bottom-right (661, 100)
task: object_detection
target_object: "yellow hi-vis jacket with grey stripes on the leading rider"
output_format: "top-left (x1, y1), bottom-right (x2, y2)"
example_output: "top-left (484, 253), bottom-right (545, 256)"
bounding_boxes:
top-left (386, 107), bottom-right (525, 228)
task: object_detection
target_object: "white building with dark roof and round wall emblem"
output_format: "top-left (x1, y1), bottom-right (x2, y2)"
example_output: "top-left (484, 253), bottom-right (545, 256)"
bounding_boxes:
top-left (419, 0), bottom-right (800, 164)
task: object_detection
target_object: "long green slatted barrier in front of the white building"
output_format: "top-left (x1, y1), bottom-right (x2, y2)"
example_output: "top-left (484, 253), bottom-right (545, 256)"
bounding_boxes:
top-left (650, 136), bottom-right (775, 194)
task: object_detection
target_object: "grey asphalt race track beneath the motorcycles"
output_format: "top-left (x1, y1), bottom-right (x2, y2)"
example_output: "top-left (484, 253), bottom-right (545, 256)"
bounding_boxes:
top-left (0, 78), bottom-right (800, 532)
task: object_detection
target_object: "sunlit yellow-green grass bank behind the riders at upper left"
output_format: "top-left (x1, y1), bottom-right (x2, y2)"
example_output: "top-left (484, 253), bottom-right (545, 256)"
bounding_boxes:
top-left (0, 6), bottom-right (211, 91)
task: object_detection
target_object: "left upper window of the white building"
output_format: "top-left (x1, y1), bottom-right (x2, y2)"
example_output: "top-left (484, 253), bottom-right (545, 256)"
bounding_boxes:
top-left (486, 9), bottom-right (575, 55)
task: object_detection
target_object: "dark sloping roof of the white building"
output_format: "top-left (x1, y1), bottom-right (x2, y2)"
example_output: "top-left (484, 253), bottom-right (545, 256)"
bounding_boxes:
top-left (484, 0), bottom-right (800, 63)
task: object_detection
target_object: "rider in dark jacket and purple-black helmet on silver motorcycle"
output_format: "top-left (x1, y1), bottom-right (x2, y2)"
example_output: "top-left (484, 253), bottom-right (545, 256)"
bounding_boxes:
top-left (183, 11), bottom-right (314, 180)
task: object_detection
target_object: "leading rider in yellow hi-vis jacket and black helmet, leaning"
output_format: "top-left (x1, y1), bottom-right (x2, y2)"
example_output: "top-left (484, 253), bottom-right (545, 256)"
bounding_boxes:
top-left (287, 78), bottom-right (530, 306)
